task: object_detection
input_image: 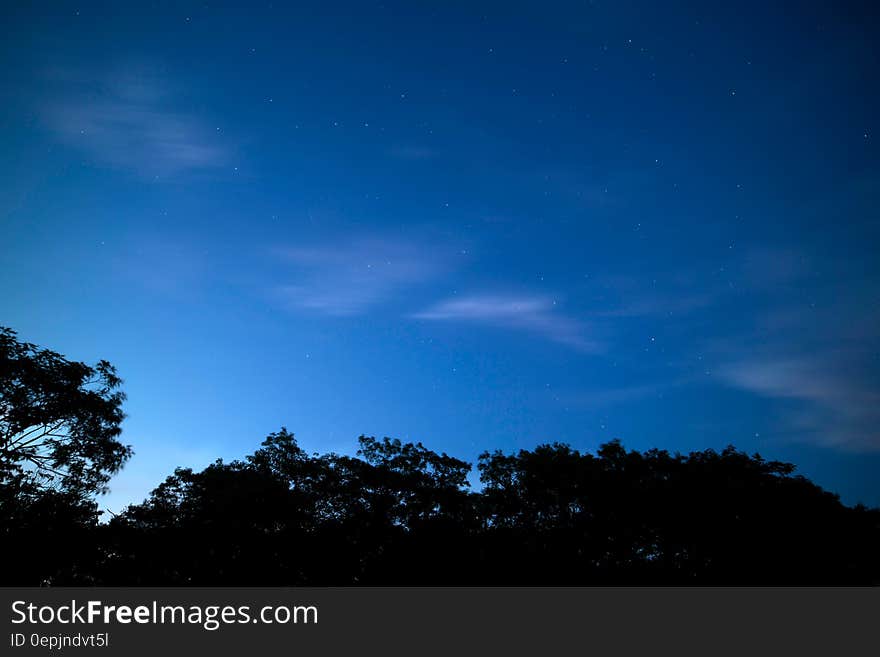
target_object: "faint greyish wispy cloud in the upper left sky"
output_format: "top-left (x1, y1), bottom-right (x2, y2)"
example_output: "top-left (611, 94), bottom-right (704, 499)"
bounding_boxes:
top-left (43, 72), bottom-right (227, 175)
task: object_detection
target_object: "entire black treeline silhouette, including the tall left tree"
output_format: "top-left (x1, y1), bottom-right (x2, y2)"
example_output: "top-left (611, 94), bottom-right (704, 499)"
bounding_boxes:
top-left (0, 330), bottom-right (880, 586)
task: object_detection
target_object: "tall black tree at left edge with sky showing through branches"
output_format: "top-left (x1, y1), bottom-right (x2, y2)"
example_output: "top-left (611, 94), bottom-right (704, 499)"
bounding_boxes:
top-left (0, 327), bottom-right (131, 584)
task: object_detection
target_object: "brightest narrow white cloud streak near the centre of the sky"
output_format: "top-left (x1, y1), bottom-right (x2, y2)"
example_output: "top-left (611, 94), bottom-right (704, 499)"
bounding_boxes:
top-left (414, 295), bottom-right (601, 352)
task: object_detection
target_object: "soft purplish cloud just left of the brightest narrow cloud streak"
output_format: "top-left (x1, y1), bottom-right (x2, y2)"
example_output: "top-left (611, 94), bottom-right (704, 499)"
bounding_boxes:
top-left (275, 237), bottom-right (448, 316)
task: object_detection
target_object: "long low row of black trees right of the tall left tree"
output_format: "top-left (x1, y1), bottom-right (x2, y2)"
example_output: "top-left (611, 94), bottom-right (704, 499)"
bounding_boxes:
top-left (98, 429), bottom-right (880, 585)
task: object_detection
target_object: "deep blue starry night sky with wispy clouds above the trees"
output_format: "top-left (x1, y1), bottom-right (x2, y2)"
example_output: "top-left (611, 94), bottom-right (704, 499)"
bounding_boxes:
top-left (0, 2), bottom-right (880, 511)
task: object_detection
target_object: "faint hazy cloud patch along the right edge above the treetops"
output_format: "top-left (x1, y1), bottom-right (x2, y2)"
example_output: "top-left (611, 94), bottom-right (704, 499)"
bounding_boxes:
top-left (707, 245), bottom-right (880, 451)
